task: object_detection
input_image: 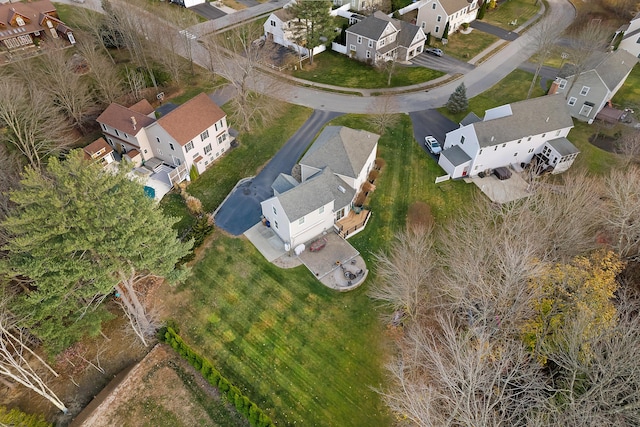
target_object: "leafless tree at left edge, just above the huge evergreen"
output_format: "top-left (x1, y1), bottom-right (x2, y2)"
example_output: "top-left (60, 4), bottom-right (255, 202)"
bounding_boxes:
top-left (0, 76), bottom-right (73, 169)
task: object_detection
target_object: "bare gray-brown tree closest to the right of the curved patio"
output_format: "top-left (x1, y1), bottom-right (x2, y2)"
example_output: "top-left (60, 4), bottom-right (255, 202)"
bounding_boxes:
top-left (369, 227), bottom-right (437, 321)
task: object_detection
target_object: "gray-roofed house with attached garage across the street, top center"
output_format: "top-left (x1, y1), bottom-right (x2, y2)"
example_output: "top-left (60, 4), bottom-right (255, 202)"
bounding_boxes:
top-left (346, 11), bottom-right (427, 64)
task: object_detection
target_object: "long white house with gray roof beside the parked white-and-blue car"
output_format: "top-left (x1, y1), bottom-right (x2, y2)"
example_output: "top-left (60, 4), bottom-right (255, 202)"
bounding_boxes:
top-left (438, 95), bottom-right (579, 178)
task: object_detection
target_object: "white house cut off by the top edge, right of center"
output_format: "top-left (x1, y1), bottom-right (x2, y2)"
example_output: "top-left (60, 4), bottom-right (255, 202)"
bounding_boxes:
top-left (416, 0), bottom-right (479, 38)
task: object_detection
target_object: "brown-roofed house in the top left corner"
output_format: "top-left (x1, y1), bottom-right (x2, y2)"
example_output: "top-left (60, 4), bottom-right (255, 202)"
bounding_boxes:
top-left (0, 0), bottom-right (76, 51)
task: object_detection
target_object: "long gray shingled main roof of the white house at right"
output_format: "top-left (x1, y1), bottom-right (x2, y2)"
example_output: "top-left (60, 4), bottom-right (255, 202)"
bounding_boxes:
top-left (471, 95), bottom-right (573, 147)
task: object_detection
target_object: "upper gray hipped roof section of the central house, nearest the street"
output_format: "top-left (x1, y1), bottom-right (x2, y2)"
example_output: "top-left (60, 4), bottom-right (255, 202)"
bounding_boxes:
top-left (300, 126), bottom-right (380, 178)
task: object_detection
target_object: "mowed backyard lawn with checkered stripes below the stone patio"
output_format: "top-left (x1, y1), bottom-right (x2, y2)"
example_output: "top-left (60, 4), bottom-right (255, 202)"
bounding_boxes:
top-left (170, 234), bottom-right (392, 426)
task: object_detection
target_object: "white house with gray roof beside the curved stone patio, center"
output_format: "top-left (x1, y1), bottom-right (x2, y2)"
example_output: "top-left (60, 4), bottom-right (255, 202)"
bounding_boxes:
top-left (261, 126), bottom-right (380, 248)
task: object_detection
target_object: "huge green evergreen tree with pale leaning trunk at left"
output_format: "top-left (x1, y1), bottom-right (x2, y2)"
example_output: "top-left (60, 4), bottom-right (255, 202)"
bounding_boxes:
top-left (0, 151), bottom-right (191, 351)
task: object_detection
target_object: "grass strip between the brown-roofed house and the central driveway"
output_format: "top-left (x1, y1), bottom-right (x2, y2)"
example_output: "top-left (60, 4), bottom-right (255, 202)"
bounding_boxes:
top-left (187, 105), bottom-right (311, 212)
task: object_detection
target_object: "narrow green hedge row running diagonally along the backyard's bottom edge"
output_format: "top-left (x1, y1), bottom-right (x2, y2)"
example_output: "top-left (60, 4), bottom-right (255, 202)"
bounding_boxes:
top-left (160, 326), bottom-right (274, 427)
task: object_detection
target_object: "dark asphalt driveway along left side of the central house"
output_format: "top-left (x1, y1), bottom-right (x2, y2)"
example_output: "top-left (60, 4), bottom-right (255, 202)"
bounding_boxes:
top-left (215, 110), bottom-right (342, 236)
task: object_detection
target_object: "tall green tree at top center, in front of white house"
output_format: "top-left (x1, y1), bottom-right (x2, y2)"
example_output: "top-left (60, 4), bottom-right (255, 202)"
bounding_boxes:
top-left (289, 0), bottom-right (335, 64)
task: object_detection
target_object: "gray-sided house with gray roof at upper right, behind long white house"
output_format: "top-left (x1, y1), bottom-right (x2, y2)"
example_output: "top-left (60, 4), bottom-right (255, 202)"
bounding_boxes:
top-left (549, 49), bottom-right (636, 123)
